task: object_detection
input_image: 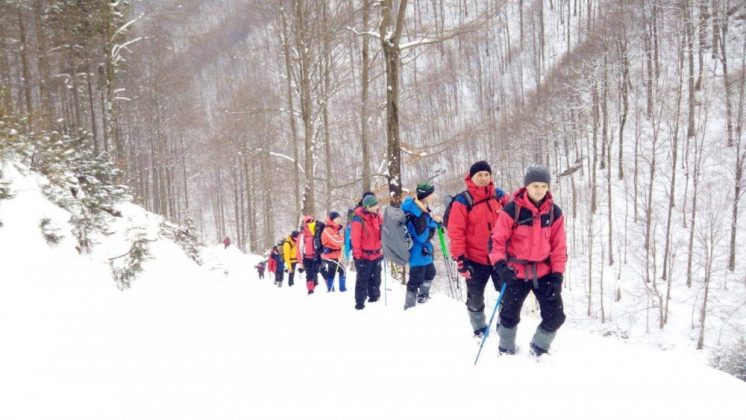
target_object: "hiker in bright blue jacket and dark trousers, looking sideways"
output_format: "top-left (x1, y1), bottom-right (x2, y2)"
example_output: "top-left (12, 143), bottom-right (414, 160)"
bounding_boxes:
top-left (401, 182), bottom-right (441, 310)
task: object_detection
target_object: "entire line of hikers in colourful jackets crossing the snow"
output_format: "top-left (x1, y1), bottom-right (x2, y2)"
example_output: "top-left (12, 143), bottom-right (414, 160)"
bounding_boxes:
top-left (251, 161), bottom-right (567, 356)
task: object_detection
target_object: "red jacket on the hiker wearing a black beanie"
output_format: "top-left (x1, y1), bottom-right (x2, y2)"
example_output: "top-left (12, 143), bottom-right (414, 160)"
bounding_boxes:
top-left (448, 174), bottom-right (502, 265)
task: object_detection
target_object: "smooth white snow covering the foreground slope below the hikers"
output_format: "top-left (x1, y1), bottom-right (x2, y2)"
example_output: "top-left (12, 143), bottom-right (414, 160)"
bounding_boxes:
top-left (0, 159), bottom-right (746, 420)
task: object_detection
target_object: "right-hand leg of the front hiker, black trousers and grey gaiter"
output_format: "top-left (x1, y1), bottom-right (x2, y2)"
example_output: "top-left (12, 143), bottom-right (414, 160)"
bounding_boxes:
top-left (531, 276), bottom-right (565, 355)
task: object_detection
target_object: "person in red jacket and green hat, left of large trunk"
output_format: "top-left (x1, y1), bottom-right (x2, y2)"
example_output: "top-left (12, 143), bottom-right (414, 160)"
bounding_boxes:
top-left (350, 194), bottom-right (383, 310)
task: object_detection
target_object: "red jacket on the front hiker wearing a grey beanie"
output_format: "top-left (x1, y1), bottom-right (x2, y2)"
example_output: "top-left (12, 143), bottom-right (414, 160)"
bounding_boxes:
top-left (490, 188), bottom-right (567, 279)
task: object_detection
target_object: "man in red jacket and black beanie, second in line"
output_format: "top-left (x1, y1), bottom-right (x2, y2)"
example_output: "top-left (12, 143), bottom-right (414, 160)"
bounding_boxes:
top-left (447, 161), bottom-right (503, 338)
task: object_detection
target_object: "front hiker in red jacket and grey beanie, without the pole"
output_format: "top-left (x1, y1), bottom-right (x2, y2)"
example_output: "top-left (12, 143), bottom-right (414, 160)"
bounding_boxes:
top-left (490, 166), bottom-right (567, 356)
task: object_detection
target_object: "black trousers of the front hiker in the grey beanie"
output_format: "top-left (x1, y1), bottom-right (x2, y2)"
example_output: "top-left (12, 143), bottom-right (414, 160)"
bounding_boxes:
top-left (500, 276), bottom-right (565, 332)
